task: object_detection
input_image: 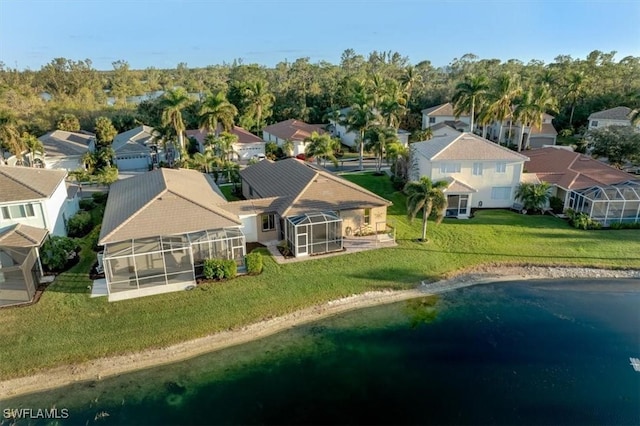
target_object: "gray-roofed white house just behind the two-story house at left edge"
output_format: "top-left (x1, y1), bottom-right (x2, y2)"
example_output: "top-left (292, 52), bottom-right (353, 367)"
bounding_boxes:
top-left (38, 130), bottom-right (96, 172)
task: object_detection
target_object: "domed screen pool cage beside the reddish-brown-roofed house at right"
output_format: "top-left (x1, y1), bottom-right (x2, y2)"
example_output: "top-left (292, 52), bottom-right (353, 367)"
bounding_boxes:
top-left (568, 181), bottom-right (640, 226)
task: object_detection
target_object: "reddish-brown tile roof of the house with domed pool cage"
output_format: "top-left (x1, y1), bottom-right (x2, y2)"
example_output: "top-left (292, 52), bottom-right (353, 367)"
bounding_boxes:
top-left (525, 147), bottom-right (635, 189)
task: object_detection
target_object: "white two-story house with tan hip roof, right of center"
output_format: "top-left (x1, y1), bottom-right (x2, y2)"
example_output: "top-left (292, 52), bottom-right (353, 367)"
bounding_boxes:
top-left (409, 133), bottom-right (529, 218)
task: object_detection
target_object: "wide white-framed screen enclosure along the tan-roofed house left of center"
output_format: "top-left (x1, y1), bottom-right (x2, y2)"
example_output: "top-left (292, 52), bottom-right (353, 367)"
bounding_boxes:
top-left (103, 228), bottom-right (245, 293)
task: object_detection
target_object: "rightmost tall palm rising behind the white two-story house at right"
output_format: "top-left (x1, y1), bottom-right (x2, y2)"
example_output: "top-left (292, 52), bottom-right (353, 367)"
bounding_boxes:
top-left (513, 85), bottom-right (557, 152)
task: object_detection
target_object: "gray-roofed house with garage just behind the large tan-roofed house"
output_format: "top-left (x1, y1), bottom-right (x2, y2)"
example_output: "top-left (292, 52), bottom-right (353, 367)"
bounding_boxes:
top-left (111, 125), bottom-right (158, 172)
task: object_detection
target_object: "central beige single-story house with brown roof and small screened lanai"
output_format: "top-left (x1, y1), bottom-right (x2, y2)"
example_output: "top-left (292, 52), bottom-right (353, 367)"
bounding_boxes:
top-left (239, 158), bottom-right (391, 256)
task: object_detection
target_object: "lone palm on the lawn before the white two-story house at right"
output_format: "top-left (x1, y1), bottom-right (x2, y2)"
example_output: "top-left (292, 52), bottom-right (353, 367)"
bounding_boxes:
top-left (404, 176), bottom-right (449, 241)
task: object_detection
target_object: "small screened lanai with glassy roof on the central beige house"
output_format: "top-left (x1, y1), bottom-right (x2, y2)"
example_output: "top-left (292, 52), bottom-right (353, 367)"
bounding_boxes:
top-left (285, 212), bottom-right (342, 257)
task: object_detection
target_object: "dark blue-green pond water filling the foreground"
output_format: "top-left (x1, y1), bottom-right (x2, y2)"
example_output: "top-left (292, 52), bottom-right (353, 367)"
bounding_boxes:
top-left (0, 280), bottom-right (640, 425)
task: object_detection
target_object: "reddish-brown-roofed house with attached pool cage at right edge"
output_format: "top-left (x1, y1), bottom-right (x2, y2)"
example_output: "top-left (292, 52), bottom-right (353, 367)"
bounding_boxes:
top-left (525, 147), bottom-right (640, 225)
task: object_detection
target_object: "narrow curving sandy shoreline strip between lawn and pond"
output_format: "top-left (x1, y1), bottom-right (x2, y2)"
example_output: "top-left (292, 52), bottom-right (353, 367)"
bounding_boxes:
top-left (0, 266), bottom-right (640, 400)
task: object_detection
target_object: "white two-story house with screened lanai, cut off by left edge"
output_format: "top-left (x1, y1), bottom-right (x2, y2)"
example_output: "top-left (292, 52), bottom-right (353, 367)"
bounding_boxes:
top-left (0, 166), bottom-right (79, 306)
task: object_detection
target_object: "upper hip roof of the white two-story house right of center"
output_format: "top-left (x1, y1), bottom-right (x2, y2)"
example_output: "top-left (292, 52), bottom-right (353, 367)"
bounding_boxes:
top-left (411, 133), bottom-right (529, 161)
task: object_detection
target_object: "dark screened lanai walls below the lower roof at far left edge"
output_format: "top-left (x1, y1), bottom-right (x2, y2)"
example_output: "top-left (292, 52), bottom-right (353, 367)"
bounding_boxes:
top-left (0, 247), bottom-right (41, 306)
